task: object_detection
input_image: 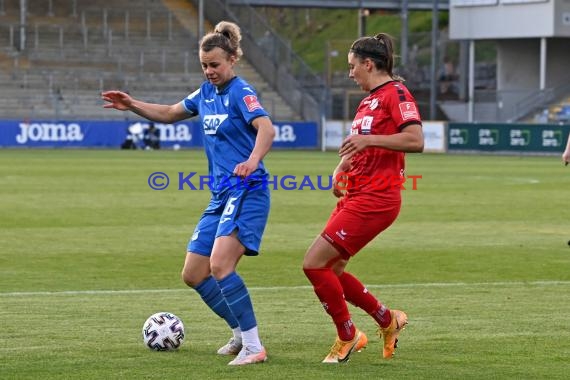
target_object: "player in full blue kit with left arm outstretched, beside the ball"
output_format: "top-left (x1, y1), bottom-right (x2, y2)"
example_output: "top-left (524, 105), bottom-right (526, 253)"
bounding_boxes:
top-left (102, 21), bottom-right (275, 365)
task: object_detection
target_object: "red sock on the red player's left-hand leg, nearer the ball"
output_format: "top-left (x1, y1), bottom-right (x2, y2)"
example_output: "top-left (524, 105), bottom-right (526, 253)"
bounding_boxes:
top-left (303, 268), bottom-right (356, 341)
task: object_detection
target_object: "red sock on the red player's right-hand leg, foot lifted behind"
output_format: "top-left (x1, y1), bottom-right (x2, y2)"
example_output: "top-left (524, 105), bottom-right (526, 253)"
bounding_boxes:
top-left (338, 272), bottom-right (392, 327)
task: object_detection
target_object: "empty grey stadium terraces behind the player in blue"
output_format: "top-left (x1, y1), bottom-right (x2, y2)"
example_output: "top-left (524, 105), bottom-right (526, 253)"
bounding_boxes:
top-left (0, 0), bottom-right (299, 120)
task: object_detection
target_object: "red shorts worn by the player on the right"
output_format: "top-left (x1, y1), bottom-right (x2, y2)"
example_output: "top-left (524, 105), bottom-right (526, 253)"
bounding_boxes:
top-left (321, 197), bottom-right (400, 260)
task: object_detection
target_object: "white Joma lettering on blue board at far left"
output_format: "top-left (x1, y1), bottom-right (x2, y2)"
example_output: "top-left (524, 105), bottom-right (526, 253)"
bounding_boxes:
top-left (16, 123), bottom-right (83, 144)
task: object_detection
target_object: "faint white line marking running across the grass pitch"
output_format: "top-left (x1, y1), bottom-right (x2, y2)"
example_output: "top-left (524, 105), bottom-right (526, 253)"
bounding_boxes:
top-left (0, 281), bottom-right (570, 297)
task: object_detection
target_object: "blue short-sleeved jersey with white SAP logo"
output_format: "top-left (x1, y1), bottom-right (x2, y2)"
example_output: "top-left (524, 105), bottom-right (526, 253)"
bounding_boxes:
top-left (182, 77), bottom-right (269, 206)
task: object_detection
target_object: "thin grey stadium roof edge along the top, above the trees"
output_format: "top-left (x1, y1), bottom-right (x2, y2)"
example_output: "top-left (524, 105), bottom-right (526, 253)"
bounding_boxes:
top-left (226, 0), bottom-right (449, 10)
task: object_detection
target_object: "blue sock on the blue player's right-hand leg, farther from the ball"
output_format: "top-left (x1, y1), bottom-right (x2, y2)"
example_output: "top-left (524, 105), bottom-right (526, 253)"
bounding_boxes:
top-left (218, 272), bottom-right (257, 331)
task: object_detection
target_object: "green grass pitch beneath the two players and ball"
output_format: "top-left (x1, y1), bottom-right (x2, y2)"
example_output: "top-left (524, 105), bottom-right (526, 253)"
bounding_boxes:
top-left (0, 150), bottom-right (570, 380)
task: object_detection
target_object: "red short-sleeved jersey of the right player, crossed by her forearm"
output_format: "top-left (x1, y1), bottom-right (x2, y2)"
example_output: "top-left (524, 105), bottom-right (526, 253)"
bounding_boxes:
top-left (347, 81), bottom-right (421, 209)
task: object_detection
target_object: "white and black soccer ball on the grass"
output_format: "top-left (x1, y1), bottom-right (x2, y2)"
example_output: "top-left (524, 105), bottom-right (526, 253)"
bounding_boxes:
top-left (142, 312), bottom-right (184, 351)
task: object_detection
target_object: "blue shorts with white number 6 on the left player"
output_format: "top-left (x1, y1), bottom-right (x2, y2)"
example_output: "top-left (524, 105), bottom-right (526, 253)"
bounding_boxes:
top-left (187, 187), bottom-right (270, 256)
